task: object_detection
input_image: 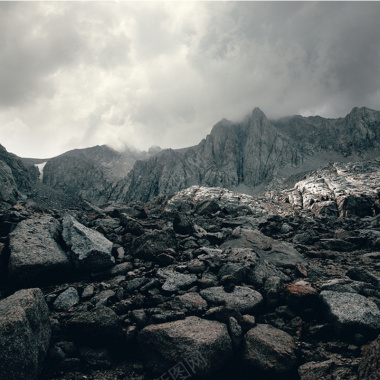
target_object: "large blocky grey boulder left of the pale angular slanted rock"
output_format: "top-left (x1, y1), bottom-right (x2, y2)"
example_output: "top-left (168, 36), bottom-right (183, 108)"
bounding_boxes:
top-left (8, 215), bottom-right (71, 283)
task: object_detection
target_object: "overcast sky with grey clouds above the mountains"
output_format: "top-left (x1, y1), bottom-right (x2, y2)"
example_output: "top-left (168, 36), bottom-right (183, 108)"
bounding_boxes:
top-left (0, 1), bottom-right (380, 158)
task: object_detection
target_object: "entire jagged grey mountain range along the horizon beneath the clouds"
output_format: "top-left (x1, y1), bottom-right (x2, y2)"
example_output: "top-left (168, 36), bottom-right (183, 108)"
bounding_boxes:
top-left (0, 107), bottom-right (380, 209)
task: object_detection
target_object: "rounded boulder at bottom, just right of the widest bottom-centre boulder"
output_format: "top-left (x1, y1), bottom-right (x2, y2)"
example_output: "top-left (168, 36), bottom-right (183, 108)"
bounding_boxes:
top-left (243, 324), bottom-right (298, 375)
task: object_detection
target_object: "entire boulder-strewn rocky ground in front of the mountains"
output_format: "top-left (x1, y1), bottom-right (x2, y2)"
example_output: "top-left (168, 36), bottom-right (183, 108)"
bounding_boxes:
top-left (0, 160), bottom-right (380, 380)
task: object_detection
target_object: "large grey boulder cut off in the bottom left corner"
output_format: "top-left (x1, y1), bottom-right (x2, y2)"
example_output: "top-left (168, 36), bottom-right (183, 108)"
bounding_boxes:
top-left (0, 289), bottom-right (51, 380)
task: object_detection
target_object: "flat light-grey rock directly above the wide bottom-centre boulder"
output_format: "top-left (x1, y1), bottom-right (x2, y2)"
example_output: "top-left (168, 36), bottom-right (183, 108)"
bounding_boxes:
top-left (200, 286), bottom-right (263, 313)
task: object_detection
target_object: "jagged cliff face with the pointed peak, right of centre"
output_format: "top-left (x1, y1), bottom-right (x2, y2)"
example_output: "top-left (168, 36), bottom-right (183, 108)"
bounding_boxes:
top-left (123, 108), bottom-right (380, 201)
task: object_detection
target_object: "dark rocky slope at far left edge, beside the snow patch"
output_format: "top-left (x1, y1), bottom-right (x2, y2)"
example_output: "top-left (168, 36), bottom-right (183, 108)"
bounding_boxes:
top-left (0, 145), bottom-right (36, 205)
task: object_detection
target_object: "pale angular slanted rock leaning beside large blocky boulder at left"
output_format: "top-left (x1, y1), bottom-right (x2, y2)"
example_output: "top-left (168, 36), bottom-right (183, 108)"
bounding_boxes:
top-left (62, 215), bottom-right (115, 271)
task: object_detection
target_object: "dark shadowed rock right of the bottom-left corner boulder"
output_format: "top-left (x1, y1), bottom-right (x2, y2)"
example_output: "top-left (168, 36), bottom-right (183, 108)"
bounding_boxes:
top-left (66, 305), bottom-right (124, 348)
